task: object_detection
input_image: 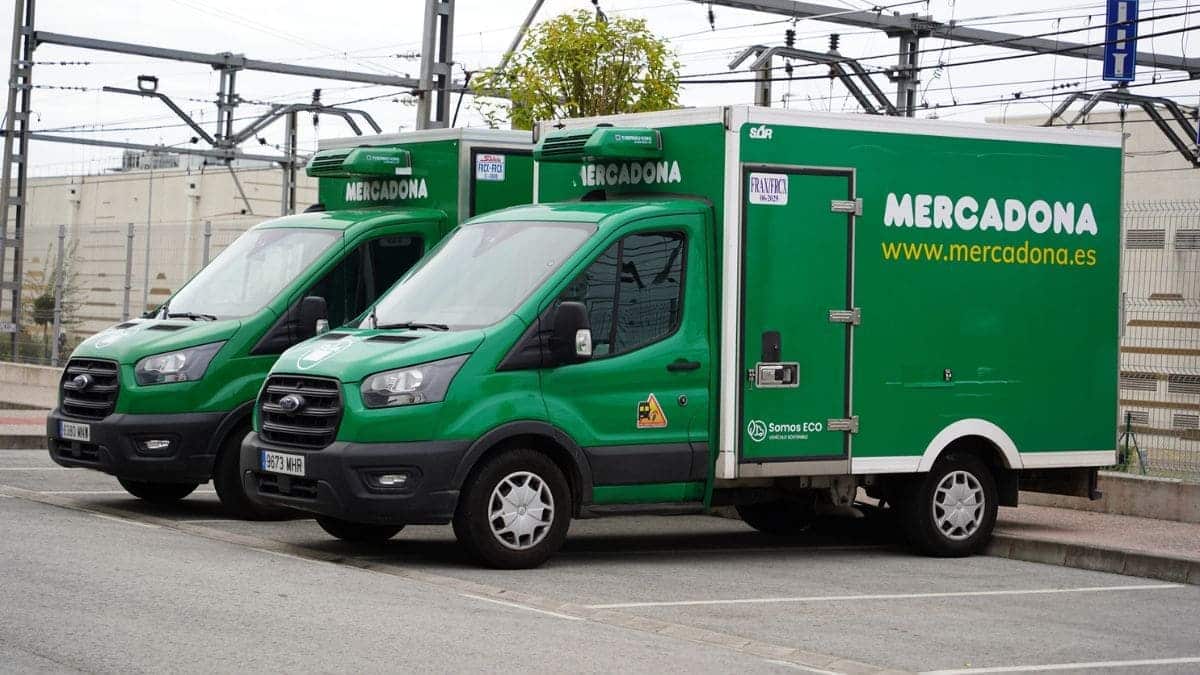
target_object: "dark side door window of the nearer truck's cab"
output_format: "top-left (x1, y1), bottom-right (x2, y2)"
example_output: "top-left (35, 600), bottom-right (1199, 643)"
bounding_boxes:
top-left (558, 232), bottom-right (686, 357)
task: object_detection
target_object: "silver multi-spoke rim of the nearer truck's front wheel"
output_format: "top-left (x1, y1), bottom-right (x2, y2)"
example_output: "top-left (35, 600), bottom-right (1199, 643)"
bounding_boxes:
top-left (487, 471), bottom-right (554, 551)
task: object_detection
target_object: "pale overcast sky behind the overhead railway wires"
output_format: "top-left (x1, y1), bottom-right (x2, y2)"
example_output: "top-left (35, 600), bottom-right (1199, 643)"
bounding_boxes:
top-left (4, 0), bottom-right (1200, 174)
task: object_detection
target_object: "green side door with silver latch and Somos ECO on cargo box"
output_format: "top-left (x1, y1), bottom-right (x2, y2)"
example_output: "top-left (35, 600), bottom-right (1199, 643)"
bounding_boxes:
top-left (740, 168), bottom-right (850, 461)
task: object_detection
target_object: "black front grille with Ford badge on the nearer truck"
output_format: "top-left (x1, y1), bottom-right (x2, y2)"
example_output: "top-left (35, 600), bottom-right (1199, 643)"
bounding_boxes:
top-left (258, 375), bottom-right (342, 449)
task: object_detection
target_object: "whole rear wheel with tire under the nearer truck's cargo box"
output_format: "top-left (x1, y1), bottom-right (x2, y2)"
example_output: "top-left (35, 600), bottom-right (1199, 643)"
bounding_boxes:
top-left (896, 454), bottom-right (1000, 557)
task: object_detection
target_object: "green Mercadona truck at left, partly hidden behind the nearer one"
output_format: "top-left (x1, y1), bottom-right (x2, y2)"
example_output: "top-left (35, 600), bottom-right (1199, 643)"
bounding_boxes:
top-left (47, 130), bottom-right (533, 518)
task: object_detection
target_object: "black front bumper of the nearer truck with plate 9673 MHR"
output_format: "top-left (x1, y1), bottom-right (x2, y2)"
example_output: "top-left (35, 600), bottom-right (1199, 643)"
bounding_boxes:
top-left (241, 434), bottom-right (470, 525)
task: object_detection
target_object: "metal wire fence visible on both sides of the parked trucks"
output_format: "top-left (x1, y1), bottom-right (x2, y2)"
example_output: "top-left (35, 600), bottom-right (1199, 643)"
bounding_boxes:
top-left (7, 201), bottom-right (1200, 480)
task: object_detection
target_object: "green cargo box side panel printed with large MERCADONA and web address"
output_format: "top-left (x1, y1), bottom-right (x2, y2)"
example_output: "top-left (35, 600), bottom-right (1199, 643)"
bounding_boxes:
top-left (742, 123), bottom-right (1121, 458)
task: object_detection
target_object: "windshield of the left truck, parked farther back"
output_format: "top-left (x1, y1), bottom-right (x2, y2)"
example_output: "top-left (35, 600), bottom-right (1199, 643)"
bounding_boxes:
top-left (167, 227), bottom-right (342, 318)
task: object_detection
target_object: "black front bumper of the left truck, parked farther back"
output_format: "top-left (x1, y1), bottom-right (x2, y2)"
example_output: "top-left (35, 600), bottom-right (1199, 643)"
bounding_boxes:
top-left (46, 408), bottom-right (227, 483)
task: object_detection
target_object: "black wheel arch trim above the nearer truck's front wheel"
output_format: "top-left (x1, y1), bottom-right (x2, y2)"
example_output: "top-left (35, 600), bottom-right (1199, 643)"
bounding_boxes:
top-left (452, 420), bottom-right (592, 515)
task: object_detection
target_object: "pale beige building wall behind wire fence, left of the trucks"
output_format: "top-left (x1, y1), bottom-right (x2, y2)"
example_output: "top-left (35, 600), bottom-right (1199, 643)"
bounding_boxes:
top-left (0, 166), bottom-right (316, 365)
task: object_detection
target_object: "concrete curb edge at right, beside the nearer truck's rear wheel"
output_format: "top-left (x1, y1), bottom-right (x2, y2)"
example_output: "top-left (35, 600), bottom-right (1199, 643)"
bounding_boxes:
top-left (985, 534), bottom-right (1200, 585)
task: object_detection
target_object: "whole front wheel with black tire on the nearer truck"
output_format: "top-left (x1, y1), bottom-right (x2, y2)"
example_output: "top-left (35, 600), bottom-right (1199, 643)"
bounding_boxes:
top-left (454, 448), bottom-right (571, 569)
